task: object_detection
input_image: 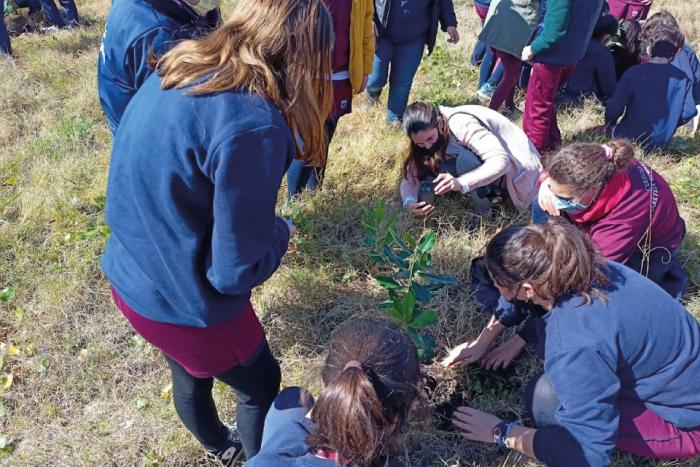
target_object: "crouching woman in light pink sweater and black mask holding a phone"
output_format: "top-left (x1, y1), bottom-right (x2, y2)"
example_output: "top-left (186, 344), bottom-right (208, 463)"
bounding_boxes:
top-left (401, 102), bottom-right (542, 215)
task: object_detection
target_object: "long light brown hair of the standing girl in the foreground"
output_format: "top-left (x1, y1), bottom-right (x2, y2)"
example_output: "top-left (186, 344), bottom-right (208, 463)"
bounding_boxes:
top-left (156, 0), bottom-right (334, 165)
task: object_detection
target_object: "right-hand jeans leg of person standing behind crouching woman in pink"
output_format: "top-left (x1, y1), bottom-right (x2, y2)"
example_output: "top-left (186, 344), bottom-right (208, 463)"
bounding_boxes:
top-left (387, 37), bottom-right (425, 121)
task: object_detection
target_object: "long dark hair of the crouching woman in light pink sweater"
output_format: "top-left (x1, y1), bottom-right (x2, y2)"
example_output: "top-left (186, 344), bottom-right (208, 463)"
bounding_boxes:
top-left (402, 102), bottom-right (450, 180)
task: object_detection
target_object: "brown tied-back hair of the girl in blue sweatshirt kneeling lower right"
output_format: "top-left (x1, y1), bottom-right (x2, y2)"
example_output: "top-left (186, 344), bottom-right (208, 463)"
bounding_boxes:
top-left (485, 220), bottom-right (609, 304)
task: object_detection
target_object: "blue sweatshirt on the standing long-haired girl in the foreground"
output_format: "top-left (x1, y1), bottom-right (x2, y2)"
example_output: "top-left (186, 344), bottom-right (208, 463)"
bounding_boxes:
top-left (101, 74), bottom-right (296, 327)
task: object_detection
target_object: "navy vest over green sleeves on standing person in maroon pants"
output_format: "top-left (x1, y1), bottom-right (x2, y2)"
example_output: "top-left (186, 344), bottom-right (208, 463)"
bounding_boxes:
top-left (532, 0), bottom-right (604, 66)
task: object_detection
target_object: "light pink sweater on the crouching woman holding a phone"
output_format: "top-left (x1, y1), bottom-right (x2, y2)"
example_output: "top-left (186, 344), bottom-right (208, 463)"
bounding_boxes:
top-left (401, 105), bottom-right (542, 209)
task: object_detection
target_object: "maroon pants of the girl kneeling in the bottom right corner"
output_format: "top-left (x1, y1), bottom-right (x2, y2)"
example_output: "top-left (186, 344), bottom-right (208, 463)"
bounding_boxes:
top-left (617, 399), bottom-right (700, 459)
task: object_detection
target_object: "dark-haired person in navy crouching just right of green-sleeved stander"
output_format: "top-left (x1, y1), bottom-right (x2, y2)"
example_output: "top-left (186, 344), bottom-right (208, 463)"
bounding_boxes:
top-left (558, 15), bottom-right (617, 105)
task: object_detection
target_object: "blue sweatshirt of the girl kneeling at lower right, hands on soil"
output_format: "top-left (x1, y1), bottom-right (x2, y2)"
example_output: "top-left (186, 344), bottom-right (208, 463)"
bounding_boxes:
top-left (534, 262), bottom-right (700, 467)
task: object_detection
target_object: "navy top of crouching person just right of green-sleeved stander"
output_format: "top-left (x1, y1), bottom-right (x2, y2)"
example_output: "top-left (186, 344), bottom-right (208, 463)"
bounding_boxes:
top-left (564, 39), bottom-right (617, 101)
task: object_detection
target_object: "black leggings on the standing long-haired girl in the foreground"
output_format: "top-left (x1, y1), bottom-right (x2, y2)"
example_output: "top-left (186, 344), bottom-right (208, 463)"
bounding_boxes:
top-left (165, 342), bottom-right (281, 459)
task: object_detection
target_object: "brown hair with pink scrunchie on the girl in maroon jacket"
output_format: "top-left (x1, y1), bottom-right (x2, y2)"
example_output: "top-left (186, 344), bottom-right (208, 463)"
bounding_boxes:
top-left (546, 139), bottom-right (634, 194)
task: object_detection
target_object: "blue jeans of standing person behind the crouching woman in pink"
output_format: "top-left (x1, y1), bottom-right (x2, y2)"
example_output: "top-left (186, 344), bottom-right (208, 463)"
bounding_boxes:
top-left (367, 37), bottom-right (425, 122)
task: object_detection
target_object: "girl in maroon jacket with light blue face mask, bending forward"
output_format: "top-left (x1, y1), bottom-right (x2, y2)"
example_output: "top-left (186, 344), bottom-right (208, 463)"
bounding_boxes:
top-left (538, 140), bottom-right (687, 297)
